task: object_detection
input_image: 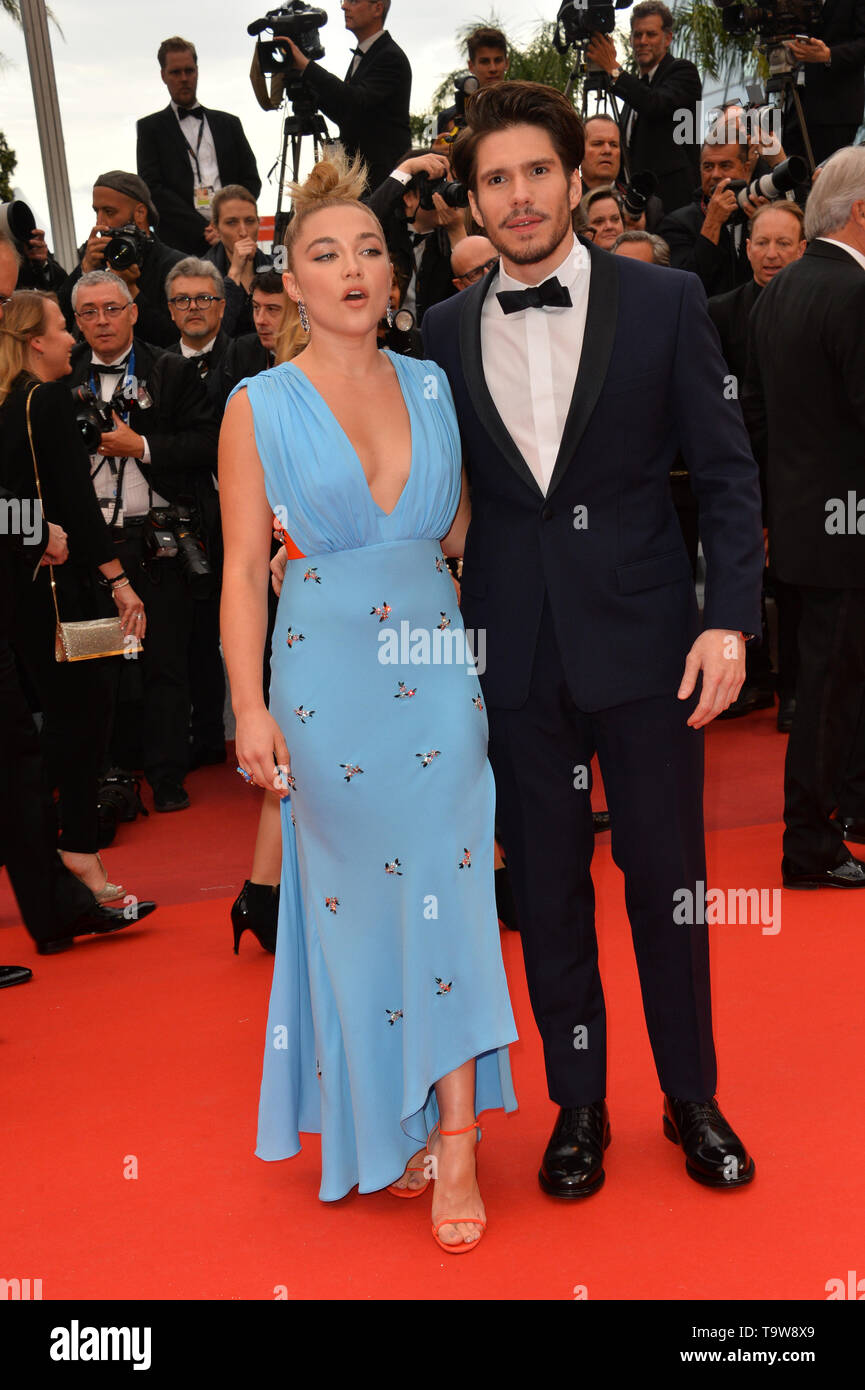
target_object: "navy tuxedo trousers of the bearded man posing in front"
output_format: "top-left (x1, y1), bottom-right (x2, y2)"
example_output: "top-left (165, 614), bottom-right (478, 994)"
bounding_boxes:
top-left (488, 603), bottom-right (716, 1106)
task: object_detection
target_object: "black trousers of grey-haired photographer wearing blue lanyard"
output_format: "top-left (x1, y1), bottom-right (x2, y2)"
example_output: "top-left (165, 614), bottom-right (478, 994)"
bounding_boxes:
top-left (111, 525), bottom-right (195, 787)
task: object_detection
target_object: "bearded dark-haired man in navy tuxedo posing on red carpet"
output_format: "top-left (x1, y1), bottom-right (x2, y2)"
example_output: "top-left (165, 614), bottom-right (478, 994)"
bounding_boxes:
top-left (423, 82), bottom-right (763, 1198)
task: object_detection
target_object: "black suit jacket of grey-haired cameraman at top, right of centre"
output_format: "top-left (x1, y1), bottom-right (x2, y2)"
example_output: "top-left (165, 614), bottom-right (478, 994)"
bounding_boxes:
top-left (611, 53), bottom-right (702, 214)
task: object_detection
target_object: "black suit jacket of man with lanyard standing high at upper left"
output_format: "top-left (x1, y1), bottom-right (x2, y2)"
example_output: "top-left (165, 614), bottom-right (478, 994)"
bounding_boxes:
top-left (135, 103), bottom-right (261, 256)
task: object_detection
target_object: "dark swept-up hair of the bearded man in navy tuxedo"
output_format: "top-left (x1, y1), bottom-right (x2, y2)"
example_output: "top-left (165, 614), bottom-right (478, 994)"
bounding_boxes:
top-left (451, 82), bottom-right (585, 193)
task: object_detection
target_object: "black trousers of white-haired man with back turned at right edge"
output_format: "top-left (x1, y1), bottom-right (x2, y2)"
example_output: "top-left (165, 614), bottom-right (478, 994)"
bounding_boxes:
top-left (783, 587), bottom-right (865, 873)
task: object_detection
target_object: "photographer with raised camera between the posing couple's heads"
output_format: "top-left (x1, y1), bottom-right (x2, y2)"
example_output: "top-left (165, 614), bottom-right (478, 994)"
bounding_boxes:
top-left (367, 153), bottom-right (466, 325)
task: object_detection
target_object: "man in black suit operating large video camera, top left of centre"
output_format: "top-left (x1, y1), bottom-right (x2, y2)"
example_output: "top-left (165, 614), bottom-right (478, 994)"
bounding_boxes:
top-left (278, 0), bottom-right (412, 197)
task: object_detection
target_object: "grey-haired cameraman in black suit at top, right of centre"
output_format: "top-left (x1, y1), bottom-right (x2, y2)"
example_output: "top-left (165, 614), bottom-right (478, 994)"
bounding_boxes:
top-left (585, 0), bottom-right (702, 213)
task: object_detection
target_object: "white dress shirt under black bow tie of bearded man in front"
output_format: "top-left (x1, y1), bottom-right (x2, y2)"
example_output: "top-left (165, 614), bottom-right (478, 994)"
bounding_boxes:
top-left (481, 236), bottom-right (591, 495)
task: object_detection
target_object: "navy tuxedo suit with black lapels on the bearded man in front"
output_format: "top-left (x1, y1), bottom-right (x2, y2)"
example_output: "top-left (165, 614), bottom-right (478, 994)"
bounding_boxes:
top-left (424, 245), bottom-right (762, 1106)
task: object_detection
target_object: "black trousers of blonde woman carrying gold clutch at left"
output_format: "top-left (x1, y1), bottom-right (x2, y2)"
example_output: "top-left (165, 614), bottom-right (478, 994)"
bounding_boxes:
top-left (14, 574), bottom-right (120, 855)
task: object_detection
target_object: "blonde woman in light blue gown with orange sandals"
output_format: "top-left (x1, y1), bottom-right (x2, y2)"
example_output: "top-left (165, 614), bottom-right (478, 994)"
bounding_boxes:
top-left (220, 152), bottom-right (516, 1254)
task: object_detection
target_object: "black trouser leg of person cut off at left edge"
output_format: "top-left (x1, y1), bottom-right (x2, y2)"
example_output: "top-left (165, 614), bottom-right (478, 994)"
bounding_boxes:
top-left (0, 641), bottom-right (96, 941)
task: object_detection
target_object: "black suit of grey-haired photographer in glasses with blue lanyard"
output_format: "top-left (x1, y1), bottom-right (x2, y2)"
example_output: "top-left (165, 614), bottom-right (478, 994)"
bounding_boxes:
top-left (67, 339), bottom-right (218, 785)
